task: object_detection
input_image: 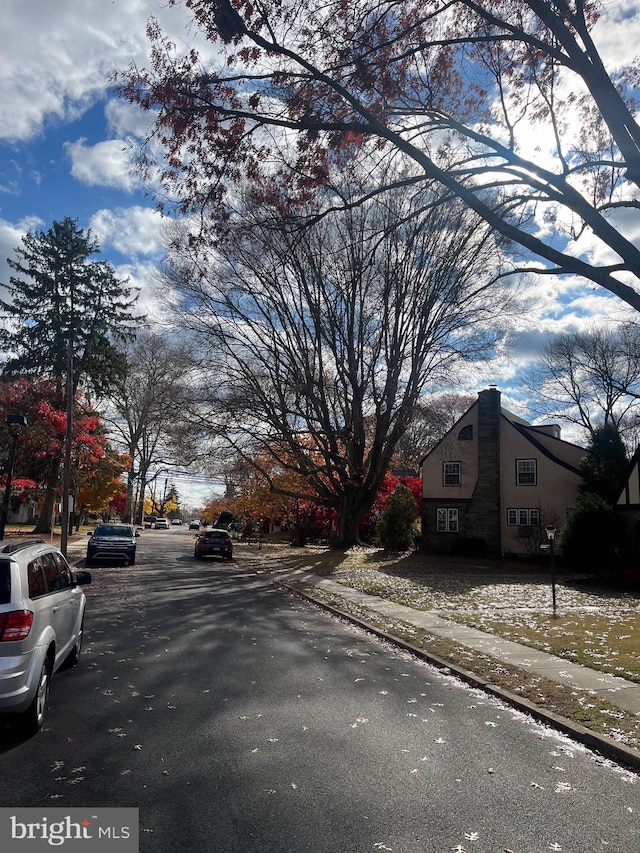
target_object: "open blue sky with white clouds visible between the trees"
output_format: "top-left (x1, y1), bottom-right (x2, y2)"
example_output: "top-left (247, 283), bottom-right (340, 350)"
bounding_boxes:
top-left (0, 0), bottom-right (640, 502)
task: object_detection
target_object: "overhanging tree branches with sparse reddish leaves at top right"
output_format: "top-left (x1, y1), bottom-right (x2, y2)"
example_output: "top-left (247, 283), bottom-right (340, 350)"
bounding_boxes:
top-left (120, 0), bottom-right (640, 310)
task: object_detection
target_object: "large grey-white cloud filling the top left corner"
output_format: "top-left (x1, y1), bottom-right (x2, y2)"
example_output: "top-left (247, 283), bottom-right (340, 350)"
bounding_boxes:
top-left (0, 0), bottom-right (195, 141)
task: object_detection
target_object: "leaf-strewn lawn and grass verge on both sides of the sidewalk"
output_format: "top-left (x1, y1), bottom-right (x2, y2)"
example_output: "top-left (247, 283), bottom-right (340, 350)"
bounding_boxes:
top-left (244, 543), bottom-right (640, 749)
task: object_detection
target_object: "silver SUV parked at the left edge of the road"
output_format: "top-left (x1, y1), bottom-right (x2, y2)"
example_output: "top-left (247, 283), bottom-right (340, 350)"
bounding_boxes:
top-left (0, 539), bottom-right (91, 733)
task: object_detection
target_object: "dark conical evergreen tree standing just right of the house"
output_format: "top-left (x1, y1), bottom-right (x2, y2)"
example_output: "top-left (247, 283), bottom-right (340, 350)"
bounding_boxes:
top-left (580, 422), bottom-right (628, 505)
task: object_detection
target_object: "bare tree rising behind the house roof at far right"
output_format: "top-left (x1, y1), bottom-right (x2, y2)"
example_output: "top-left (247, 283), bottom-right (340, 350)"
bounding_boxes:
top-left (526, 323), bottom-right (640, 439)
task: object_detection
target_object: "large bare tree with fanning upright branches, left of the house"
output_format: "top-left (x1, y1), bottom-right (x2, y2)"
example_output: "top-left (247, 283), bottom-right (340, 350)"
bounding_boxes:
top-left (164, 185), bottom-right (508, 546)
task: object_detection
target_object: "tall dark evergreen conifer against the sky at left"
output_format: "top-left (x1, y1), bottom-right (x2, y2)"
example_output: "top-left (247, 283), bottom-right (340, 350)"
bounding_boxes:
top-left (0, 217), bottom-right (142, 400)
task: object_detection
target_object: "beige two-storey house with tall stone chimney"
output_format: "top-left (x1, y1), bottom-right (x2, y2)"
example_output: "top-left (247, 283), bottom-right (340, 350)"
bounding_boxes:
top-left (421, 386), bottom-right (585, 556)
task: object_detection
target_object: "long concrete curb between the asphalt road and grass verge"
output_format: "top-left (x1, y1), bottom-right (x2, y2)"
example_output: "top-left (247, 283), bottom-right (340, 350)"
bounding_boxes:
top-left (273, 578), bottom-right (640, 773)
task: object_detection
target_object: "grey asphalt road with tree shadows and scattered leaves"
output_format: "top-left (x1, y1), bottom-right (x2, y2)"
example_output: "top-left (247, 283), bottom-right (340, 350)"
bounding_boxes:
top-left (0, 528), bottom-right (640, 853)
